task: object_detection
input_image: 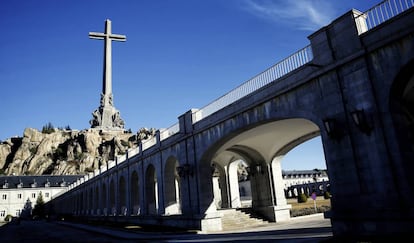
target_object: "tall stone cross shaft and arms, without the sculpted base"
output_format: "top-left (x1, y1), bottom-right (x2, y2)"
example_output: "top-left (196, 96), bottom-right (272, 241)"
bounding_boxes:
top-left (89, 19), bottom-right (126, 105)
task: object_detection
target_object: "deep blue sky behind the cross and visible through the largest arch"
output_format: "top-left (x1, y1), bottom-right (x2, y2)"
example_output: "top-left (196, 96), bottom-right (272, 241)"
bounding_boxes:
top-left (0, 0), bottom-right (380, 169)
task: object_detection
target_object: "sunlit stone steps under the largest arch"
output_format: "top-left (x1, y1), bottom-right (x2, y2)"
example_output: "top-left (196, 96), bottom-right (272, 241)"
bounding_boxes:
top-left (220, 208), bottom-right (270, 230)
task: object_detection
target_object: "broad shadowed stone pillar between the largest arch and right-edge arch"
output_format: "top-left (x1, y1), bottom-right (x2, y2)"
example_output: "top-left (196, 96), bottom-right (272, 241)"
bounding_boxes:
top-left (309, 10), bottom-right (412, 236)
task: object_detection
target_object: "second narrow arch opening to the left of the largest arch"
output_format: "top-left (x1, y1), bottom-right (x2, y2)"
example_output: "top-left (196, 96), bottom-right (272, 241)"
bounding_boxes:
top-left (145, 164), bottom-right (158, 214)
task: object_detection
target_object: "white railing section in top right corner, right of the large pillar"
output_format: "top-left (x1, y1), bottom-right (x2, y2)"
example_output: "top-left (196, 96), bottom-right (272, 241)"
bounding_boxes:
top-left (355, 0), bottom-right (414, 34)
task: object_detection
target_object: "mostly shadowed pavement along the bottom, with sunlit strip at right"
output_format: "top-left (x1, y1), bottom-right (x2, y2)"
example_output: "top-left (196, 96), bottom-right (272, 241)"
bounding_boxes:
top-left (0, 214), bottom-right (332, 243)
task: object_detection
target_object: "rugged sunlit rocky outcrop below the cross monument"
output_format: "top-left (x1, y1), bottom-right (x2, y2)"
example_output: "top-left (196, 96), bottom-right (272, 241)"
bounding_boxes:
top-left (0, 128), bottom-right (155, 175)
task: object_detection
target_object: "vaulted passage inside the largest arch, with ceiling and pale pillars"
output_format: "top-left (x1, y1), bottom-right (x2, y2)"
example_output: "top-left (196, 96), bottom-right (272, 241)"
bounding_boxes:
top-left (209, 118), bottom-right (319, 221)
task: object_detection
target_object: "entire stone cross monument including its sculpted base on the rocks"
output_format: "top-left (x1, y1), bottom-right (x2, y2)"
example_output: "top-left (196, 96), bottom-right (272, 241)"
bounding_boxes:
top-left (89, 19), bottom-right (126, 131)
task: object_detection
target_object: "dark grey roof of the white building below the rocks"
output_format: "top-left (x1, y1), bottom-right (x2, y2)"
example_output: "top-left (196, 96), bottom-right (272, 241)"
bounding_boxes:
top-left (0, 175), bottom-right (83, 190)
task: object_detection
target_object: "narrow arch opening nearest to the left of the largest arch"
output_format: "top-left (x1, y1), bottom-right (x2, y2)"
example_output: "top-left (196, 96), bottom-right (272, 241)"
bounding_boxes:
top-left (164, 156), bottom-right (181, 215)
